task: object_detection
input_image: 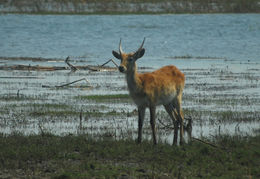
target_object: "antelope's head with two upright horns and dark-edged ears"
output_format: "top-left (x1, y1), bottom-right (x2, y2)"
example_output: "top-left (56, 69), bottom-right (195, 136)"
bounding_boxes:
top-left (112, 38), bottom-right (145, 73)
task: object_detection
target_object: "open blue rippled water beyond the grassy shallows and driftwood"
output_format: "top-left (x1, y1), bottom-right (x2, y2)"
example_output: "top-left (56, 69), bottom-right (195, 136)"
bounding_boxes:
top-left (0, 14), bottom-right (260, 66)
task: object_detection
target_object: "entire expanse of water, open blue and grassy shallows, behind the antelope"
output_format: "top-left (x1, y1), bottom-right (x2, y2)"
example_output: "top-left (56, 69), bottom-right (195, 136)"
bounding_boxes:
top-left (0, 14), bottom-right (260, 142)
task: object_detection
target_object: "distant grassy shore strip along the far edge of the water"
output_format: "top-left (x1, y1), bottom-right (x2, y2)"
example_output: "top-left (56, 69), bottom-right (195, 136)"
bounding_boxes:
top-left (0, 0), bottom-right (260, 14)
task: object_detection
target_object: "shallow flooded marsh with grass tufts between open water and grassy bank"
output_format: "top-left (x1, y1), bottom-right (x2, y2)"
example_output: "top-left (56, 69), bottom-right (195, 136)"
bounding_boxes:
top-left (0, 57), bottom-right (260, 143)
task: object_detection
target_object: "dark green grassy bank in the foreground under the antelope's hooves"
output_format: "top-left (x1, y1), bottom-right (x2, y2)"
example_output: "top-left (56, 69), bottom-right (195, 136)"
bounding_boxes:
top-left (0, 134), bottom-right (260, 178)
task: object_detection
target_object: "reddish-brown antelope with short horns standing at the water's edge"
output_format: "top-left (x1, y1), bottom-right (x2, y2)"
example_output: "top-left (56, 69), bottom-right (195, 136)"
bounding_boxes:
top-left (112, 38), bottom-right (185, 145)
